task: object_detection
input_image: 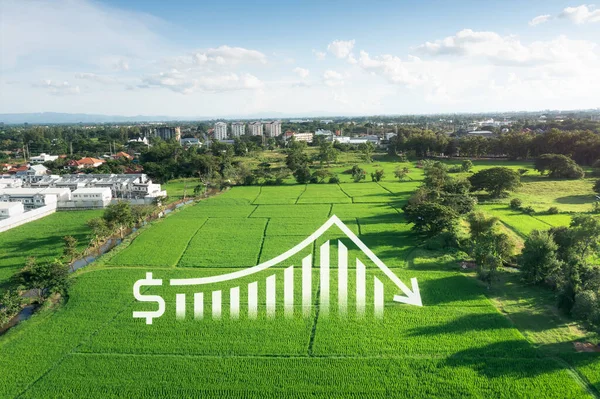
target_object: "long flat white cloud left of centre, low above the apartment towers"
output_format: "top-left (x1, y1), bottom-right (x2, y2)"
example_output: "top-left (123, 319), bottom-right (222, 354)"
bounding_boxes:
top-left (139, 69), bottom-right (263, 94)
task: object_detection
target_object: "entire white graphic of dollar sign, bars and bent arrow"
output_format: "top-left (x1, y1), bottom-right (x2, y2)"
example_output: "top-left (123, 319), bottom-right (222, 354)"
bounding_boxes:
top-left (133, 215), bottom-right (423, 324)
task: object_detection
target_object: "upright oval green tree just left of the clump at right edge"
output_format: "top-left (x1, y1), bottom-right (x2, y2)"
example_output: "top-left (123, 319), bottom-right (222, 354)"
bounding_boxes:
top-left (518, 230), bottom-right (561, 284)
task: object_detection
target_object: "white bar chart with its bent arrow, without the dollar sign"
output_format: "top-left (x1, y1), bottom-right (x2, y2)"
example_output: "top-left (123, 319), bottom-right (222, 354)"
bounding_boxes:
top-left (166, 216), bottom-right (423, 324)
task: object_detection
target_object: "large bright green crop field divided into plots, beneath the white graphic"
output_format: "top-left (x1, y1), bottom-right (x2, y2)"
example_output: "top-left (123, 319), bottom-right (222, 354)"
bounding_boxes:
top-left (0, 161), bottom-right (600, 398)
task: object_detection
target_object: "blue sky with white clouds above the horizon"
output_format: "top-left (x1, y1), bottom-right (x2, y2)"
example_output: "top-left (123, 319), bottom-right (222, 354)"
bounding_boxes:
top-left (0, 0), bottom-right (600, 117)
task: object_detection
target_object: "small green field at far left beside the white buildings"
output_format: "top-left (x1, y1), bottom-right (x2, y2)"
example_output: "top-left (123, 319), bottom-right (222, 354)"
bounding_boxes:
top-left (0, 210), bottom-right (102, 292)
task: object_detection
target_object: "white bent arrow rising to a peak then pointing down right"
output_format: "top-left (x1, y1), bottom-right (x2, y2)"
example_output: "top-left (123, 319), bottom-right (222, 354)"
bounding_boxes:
top-left (170, 215), bottom-right (423, 306)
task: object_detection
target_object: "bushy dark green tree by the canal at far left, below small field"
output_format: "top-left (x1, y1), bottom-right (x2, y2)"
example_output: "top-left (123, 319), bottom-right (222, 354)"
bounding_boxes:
top-left (17, 258), bottom-right (69, 300)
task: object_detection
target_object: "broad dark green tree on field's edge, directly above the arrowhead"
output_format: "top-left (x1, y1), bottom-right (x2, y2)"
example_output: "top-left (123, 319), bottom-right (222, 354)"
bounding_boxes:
top-left (402, 202), bottom-right (458, 237)
